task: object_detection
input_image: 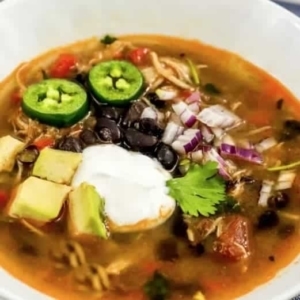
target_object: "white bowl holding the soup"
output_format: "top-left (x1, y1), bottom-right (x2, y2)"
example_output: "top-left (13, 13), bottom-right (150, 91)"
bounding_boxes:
top-left (0, 0), bottom-right (300, 300)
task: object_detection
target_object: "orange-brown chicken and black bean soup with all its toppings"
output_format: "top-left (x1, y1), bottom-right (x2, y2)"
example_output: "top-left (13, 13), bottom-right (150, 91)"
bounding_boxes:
top-left (0, 35), bottom-right (300, 300)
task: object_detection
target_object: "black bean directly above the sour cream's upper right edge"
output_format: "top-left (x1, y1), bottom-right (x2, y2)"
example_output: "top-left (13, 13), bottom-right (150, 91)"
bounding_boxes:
top-left (125, 128), bottom-right (158, 151)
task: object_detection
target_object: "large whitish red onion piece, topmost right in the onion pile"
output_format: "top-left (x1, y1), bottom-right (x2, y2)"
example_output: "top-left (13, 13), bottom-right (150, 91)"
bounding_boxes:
top-left (197, 104), bottom-right (241, 129)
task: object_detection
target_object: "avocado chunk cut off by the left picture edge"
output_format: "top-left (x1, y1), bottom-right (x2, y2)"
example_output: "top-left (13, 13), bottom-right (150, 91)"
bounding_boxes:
top-left (0, 135), bottom-right (25, 172)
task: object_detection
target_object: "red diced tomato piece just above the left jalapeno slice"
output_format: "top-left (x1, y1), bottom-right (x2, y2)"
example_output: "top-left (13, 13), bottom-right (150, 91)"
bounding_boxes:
top-left (50, 53), bottom-right (77, 78)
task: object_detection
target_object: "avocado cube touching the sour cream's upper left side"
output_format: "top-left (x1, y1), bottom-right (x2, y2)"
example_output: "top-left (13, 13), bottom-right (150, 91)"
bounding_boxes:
top-left (32, 148), bottom-right (82, 184)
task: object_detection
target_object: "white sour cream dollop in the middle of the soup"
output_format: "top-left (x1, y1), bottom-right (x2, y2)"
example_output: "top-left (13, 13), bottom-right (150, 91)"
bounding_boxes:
top-left (72, 145), bottom-right (176, 232)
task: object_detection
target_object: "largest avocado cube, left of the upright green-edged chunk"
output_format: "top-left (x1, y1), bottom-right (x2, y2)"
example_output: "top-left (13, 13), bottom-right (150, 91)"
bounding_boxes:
top-left (8, 176), bottom-right (71, 223)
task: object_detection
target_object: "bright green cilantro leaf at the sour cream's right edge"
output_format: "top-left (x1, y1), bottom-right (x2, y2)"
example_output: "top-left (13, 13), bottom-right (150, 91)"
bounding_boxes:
top-left (167, 161), bottom-right (226, 217)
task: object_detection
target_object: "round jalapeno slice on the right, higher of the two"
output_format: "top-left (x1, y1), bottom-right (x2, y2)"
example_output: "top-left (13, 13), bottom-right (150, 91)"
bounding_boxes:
top-left (88, 60), bottom-right (144, 106)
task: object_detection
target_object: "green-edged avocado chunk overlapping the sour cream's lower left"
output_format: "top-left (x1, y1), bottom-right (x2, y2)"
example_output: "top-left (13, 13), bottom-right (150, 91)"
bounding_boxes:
top-left (68, 182), bottom-right (108, 239)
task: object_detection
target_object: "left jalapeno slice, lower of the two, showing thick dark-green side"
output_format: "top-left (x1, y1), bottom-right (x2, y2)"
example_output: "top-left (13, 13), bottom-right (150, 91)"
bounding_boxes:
top-left (22, 79), bottom-right (89, 127)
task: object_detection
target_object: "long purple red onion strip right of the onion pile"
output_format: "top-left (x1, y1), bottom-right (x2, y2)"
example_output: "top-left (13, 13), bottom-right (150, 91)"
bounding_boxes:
top-left (220, 143), bottom-right (263, 164)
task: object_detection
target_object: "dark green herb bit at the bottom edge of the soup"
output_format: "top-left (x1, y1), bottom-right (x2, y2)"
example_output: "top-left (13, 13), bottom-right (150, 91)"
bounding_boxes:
top-left (144, 271), bottom-right (170, 300)
